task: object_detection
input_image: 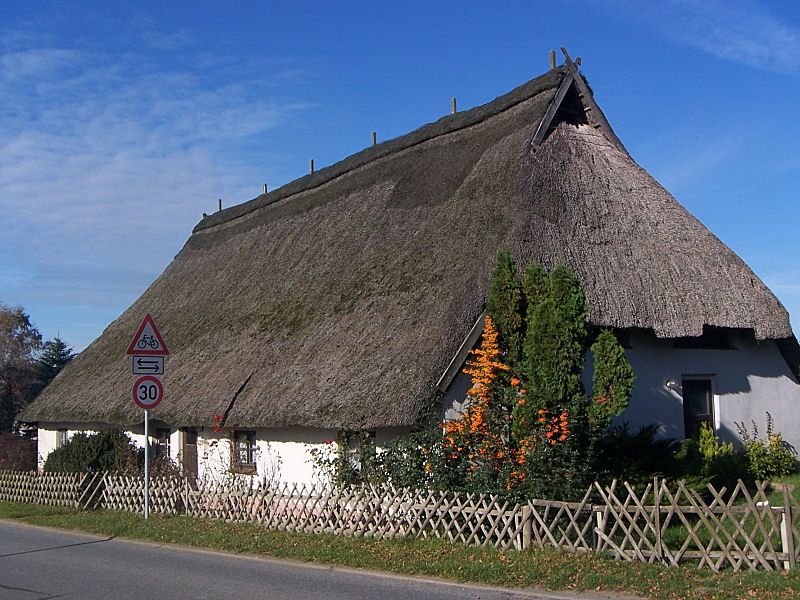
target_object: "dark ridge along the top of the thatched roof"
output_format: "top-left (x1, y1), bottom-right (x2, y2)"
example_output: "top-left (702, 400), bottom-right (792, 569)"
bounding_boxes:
top-left (192, 66), bottom-right (568, 233)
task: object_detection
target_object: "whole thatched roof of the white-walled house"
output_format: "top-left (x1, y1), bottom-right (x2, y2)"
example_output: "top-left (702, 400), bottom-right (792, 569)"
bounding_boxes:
top-left (23, 67), bottom-right (796, 428)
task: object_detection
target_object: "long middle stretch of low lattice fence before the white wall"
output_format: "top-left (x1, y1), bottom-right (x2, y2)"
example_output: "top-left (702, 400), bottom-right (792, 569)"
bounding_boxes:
top-left (114, 477), bottom-right (529, 550)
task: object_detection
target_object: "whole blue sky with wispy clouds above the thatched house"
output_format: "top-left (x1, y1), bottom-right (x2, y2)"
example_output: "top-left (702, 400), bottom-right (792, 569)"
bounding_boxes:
top-left (0, 0), bottom-right (800, 350)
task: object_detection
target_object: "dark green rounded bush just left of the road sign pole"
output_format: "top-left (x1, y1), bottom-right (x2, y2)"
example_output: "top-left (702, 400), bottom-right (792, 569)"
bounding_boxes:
top-left (44, 429), bottom-right (141, 473)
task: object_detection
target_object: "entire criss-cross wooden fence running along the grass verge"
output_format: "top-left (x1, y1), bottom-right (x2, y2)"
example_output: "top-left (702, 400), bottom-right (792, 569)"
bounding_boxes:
top-left (0, 471), bottom-right (800, 571)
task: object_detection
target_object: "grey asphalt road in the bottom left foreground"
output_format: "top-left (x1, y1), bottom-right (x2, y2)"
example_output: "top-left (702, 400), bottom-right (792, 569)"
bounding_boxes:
top-left (0, 521), bottom-right (600, 600)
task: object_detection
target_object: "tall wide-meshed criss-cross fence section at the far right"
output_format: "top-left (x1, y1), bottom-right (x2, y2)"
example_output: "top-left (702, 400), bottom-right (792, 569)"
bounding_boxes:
top-left (594, 481), bottom-right (800, 572)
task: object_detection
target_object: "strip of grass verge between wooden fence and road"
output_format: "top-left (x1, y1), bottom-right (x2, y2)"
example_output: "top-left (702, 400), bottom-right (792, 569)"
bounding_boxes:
top-left (0, 502), bottom-right (800, 599)
